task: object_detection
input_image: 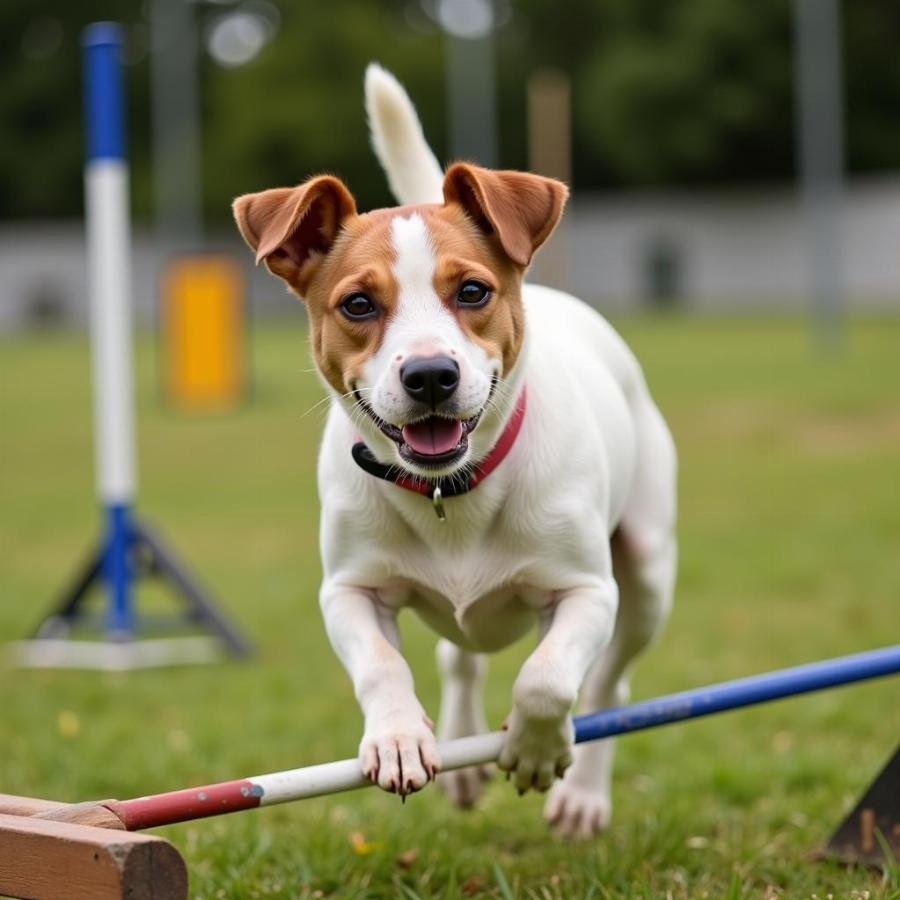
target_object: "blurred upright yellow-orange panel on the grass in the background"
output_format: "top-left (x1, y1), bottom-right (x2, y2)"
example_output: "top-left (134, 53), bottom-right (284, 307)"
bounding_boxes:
top-left (162, 255), bottom-right (246, 410)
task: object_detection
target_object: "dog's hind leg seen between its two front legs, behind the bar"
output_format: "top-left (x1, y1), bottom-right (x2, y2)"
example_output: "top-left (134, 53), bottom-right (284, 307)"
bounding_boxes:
top-left (437, 638), bottom-right (490, 807)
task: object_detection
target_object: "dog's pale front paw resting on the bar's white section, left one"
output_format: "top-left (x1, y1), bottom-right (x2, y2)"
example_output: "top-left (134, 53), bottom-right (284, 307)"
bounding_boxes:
top-left (359, 713), bottom-right (441, 797)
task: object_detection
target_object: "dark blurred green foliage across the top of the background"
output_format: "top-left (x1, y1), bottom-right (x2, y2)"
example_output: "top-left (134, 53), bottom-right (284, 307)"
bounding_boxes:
top-left (0, 0), bottom-right (900, 220)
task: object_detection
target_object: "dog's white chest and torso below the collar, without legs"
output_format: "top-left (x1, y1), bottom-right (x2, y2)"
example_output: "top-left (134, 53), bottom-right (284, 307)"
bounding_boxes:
top-left (320, 289), bottom-right (635, 651)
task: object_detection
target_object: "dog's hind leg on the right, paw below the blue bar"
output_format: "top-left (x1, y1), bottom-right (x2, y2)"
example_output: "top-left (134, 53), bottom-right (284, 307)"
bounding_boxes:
top-left (544, 404), bottom-right (677, 838)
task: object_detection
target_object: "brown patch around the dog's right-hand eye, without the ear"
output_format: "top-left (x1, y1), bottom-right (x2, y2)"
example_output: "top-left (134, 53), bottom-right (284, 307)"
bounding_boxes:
top-left (421, 205), bottom-right (525, 375)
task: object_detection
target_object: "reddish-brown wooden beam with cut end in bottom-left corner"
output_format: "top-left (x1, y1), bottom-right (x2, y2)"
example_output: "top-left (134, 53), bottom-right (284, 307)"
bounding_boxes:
top-left (0, 814), bottom-right (188, 900)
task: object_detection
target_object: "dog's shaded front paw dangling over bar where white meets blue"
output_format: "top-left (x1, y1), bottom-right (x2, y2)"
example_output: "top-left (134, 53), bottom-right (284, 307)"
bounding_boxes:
top-left (497, 706), bottom-right (575, 794)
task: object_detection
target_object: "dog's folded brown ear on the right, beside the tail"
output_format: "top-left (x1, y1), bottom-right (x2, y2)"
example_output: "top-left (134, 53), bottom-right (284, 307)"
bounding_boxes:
top-left (444, 163), bottom-right (569, 266)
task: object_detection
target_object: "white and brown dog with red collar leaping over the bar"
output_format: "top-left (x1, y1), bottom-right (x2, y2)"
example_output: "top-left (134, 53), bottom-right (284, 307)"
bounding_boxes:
top-left (234, 64), bottom-right (677, 837)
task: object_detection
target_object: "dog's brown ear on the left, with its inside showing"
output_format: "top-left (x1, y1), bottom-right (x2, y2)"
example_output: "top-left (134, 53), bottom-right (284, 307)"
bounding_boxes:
top-left (232, 175), bottom-right (356, 293)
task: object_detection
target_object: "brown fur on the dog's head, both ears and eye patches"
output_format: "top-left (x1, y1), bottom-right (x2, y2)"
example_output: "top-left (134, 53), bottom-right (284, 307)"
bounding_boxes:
top-left (234, 163), bottom-right (568, 404)
